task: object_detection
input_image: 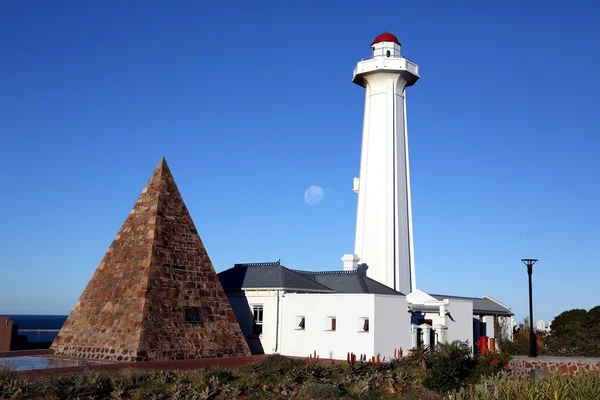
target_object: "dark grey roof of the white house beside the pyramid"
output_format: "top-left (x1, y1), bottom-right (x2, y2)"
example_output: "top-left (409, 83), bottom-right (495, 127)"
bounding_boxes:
top-left (218, 261), bottom-right (402, 295)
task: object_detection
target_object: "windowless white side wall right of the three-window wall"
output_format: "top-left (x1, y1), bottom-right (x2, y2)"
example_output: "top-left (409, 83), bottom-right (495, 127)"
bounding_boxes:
top-left (373, 295), bottom-right (412, 359)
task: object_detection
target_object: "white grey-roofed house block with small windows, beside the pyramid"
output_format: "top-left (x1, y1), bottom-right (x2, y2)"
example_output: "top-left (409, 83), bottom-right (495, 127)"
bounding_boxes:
top-left (219, 262), bottom-right (412, 359)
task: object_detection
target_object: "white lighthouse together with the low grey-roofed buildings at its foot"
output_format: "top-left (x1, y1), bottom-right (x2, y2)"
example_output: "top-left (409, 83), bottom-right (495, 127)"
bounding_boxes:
top-left (219, 33), bottom-right (513, 359)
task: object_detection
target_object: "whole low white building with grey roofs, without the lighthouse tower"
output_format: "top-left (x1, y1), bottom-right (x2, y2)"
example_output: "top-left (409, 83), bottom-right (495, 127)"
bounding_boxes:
top-left (219, 261), bottom-right (512, 359)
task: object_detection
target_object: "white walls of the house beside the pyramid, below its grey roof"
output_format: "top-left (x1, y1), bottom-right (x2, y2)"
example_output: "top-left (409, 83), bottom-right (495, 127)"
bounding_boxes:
top-left (228, 290), bottom-right (411, 360)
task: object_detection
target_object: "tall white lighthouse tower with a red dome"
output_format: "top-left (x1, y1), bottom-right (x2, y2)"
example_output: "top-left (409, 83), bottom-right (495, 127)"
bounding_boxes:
top-left (353, 33), bottom-right (419, 294)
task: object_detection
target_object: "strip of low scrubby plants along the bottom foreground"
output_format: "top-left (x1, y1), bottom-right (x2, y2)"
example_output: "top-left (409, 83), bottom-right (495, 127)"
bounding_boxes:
top-left (23, 354), bottom-right (600, 400)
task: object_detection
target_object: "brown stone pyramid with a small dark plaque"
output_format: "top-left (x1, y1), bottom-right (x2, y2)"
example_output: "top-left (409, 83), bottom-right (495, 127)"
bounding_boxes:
top-left (50, 158), bottom-right (250, 361)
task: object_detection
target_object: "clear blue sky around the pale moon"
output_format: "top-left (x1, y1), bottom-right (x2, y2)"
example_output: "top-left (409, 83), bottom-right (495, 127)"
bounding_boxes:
top-left (0, 0), bottom-right (600, 320)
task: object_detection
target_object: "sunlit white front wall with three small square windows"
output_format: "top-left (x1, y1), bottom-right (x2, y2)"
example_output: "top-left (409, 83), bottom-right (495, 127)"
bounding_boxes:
top-left (280, 294), bottom-right (372, 360)
